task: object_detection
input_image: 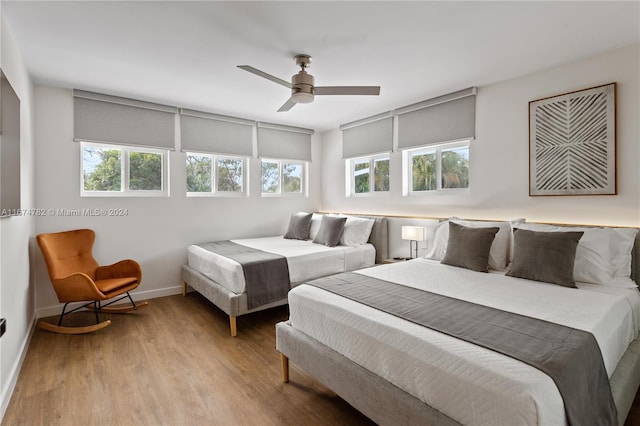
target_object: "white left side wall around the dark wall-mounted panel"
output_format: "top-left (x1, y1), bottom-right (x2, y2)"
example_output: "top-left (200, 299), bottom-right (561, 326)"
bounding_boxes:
top-left (0, 9), bottom-right (35, 418)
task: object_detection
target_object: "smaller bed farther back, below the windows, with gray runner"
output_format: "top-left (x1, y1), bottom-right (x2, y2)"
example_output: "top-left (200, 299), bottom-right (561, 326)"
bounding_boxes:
top-left (181, 213), bottom-right (388, 336)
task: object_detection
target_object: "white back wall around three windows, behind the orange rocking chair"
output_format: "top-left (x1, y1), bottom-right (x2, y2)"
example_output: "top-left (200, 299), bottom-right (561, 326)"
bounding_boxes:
top-left (35, 86), bottom-right (321, 316)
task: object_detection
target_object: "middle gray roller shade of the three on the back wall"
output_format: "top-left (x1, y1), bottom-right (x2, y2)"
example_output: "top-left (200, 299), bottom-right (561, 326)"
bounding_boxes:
top-left (180, 109), bottom-right (255, 157)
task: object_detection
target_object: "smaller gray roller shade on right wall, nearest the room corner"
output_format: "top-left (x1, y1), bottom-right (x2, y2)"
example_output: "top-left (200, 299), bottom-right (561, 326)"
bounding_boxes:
top-left (340, 112), bottom-right (393, 159)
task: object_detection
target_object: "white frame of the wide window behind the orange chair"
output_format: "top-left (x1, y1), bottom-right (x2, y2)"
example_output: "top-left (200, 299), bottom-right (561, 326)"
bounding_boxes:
top-left (80, 141), bottom-right (169, 197)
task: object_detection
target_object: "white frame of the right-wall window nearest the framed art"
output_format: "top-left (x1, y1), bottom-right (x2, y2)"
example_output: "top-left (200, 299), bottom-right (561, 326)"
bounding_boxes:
top-left (402, 139), bottom-right (471, 196)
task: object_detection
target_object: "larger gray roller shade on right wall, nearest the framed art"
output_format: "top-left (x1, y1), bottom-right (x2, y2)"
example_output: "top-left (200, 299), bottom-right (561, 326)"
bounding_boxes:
top-left (396, 87), bottom-right (476, 149)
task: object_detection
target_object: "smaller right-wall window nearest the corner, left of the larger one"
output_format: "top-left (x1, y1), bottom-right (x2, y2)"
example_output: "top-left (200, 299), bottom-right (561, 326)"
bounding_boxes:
top-left (347, 156), bottom-right (389, 195)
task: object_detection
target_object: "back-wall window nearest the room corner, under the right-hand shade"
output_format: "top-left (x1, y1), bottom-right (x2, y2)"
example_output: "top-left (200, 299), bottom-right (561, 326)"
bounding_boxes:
top-left (261, 159), bottom-right (306, 196)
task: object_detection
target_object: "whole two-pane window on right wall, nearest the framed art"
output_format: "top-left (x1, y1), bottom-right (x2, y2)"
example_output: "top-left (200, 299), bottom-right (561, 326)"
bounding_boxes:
top-left (403, 141), bottom-right (469, 195)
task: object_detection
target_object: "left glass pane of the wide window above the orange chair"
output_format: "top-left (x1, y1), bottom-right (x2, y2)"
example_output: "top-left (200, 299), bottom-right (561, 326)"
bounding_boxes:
top-left (82, 146), bottom-right (122, 191)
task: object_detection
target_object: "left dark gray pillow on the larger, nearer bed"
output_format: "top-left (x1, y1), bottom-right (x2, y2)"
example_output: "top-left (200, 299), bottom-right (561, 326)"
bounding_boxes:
top-left (440, 221), bottom-right (500, 272)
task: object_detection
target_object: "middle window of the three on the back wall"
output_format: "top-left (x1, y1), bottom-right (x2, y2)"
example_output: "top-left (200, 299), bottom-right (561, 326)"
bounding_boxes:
top-left (187, 152), bottom-right (246, 197)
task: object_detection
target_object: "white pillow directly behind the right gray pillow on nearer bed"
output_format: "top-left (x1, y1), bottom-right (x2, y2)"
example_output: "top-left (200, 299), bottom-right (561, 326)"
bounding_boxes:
top-left (517, 223), bottom-right (633, 285)
